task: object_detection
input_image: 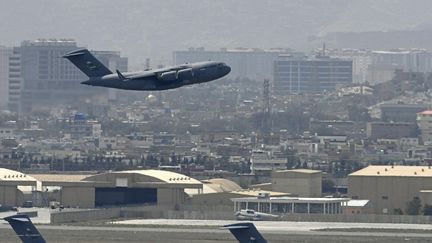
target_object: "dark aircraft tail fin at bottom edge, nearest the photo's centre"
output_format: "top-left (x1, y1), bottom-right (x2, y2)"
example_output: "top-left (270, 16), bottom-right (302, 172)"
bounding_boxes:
top-left (224, 223), bottom-right (267, 243)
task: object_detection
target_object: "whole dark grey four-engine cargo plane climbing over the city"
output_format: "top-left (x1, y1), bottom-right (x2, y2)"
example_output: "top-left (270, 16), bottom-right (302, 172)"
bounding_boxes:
top-left (63, 49), bottom-right (231, 91)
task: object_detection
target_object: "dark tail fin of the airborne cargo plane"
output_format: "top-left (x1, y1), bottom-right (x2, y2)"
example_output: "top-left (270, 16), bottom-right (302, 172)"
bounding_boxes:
top-left (63, 49), bottom-right (112, 78)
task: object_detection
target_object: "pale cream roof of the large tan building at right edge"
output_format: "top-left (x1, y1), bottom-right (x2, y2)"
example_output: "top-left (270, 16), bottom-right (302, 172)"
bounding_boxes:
top-left (349, 165), bottom-right (432, 177)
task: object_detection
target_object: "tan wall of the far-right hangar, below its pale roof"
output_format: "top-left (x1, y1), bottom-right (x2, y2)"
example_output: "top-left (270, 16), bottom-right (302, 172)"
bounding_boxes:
top-left (348, 176), bottom-right (432, 214)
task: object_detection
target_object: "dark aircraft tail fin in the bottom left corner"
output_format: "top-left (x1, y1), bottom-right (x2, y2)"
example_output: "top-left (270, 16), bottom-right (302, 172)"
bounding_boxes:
top-left (4, 214), bottom-right (46, 243)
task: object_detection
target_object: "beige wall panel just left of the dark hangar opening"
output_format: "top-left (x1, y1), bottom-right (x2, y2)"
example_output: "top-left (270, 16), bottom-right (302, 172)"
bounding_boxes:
top-left (60, 187), bottom-right (95, 208)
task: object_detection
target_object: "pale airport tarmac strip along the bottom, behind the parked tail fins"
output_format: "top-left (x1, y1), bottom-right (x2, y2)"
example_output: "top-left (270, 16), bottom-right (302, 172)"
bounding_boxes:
top-left (0, 219), bottom-right (432, 243)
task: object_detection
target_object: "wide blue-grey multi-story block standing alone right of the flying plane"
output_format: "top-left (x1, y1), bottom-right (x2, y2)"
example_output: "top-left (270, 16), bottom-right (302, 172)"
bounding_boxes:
top-left (273, 56), bottom-right (352, 95)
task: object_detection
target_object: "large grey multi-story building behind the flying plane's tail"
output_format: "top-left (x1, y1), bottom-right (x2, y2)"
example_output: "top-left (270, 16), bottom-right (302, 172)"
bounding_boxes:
top-left (19, 39), bottom-right (127, 112)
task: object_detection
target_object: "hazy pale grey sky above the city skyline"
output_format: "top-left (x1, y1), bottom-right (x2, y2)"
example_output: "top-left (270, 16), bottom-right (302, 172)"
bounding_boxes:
top-left (0, 0), bottom-right (432, 67)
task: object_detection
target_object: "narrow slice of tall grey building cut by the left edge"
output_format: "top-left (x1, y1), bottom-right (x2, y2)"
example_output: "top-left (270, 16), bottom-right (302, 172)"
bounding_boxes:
top-left (0, 46), bottom-right (12, 109)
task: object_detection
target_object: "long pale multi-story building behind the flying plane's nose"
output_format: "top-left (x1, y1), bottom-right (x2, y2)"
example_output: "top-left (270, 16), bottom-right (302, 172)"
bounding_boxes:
top-left (173, 48), bottom-right (290, 80)
